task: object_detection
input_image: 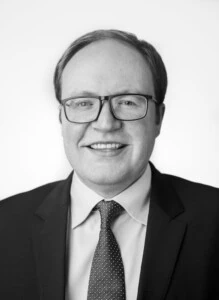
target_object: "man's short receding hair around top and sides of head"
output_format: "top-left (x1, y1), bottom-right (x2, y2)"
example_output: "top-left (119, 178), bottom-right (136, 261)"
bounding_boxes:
top-left (54, 29), bottom-right (167, 104)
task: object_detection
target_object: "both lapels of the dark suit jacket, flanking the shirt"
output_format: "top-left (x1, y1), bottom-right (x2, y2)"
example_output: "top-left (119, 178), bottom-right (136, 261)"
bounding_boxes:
top-left (32, 164), bottom-right (186, 300)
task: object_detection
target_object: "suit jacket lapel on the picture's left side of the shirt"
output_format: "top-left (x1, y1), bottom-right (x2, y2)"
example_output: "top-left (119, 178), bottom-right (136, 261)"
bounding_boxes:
top-left (32, 174), bottom-right (72, 300)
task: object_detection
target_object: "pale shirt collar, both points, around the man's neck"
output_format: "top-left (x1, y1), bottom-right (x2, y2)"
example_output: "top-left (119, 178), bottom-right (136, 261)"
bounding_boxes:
top-left (70, 164), bottom-right (151, 228)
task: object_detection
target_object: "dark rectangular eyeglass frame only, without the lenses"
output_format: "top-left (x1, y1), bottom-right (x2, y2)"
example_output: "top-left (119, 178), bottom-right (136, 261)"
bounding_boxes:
top-left (60, 93), bottom-right (159, 124)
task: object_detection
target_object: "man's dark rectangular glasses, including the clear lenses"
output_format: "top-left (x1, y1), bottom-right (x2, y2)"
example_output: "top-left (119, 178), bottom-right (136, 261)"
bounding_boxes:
top-left (61, 94), bottom-right (158, 123)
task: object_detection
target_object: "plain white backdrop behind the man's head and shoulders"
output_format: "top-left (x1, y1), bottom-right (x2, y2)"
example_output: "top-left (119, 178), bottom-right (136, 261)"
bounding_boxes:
top-left (0, 0), bottom-right (219, 199)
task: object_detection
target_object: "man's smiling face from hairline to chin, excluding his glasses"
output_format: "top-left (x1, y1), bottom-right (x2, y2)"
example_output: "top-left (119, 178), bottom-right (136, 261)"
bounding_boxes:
top-left (61, 39), bottom-right (162, 198)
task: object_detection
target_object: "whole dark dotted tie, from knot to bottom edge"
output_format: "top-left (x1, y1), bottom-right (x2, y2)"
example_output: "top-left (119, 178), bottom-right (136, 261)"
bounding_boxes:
top-left (87, 200), bottom-right (126, 300)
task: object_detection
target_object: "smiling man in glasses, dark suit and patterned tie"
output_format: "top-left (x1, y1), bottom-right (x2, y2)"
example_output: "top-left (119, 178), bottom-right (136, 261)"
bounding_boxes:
top-left (0, 30), bottom-right (219, 300)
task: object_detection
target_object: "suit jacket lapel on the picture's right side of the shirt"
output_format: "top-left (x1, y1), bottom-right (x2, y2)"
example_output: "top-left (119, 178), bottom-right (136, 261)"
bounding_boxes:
top-left (137, 165), bottom-right (186, 300)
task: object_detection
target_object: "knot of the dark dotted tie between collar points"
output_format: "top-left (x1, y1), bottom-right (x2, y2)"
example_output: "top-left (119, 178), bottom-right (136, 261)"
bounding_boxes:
top-left (96, 200), bottom-right (124, 228)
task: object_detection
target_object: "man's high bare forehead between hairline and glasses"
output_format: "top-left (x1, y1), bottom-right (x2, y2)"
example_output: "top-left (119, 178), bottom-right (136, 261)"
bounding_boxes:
top-left (62, 39), bottom-right (153, 96)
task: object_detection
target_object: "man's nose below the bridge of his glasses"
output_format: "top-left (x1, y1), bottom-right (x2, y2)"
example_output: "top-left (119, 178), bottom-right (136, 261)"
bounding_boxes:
top-left (92, 101), bottom-right (122, 131)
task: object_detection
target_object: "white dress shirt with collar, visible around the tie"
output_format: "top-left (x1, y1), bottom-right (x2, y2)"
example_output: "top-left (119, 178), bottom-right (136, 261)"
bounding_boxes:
top-left (65, 164), bottom-right (151, 300)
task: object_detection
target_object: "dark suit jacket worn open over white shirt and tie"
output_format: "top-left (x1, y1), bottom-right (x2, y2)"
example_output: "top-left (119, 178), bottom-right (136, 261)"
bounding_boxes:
top-left (0, 166), bottom-right (219, 300)
